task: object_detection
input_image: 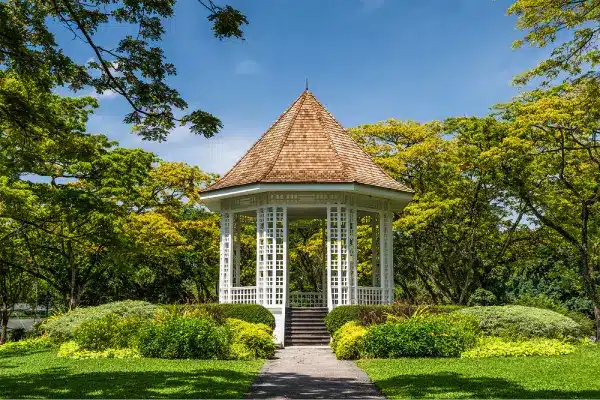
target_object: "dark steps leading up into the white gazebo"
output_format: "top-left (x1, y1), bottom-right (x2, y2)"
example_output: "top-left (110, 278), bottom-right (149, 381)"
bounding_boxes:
top-left (285, 307), bottom-right (329, 346)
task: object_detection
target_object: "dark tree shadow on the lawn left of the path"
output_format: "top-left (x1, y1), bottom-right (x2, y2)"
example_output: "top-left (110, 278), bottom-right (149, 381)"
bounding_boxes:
top-left (0, 368), bottom-right (255, 400)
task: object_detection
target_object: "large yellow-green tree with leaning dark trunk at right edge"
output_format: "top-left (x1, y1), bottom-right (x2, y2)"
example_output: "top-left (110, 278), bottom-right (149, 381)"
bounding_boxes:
top-left (488, 77), bottom-right (600, 338)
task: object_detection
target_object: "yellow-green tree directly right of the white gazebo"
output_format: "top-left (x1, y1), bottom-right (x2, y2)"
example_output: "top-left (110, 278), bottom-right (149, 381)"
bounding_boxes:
top-left (352, 118), bottom-right (523, 304)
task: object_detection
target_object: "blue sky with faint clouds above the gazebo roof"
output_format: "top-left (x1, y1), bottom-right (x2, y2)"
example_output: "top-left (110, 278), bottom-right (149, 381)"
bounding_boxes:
top-left (58, 0), bottom-right (544, 174)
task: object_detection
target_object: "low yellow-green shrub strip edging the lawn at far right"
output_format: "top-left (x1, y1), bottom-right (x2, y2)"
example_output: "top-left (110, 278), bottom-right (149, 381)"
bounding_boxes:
top-left (461, 336), bottom-right (577, 358)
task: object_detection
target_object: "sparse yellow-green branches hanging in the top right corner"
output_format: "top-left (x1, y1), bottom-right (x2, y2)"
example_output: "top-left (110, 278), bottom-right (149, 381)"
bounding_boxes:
top-left (508, 0), bottom-right (600, 85)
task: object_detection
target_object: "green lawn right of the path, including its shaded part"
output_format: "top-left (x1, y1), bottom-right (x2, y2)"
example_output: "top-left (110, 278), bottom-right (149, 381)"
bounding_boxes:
top-left (358, 345), bottom-right (600, 400)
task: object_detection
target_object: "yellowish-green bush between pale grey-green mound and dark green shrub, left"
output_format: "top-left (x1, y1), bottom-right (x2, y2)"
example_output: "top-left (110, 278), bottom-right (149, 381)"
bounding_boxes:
top-left (73, 314), bottom-right (150, 351)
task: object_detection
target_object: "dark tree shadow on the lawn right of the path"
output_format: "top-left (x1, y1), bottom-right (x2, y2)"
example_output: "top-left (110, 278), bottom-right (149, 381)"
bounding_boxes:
top-left (376, 373), bottom-right (600, 400)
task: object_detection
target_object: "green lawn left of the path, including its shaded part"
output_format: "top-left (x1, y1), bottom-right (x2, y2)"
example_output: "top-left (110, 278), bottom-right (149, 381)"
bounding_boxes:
top-left (0, 351), bottom-right (263, 400)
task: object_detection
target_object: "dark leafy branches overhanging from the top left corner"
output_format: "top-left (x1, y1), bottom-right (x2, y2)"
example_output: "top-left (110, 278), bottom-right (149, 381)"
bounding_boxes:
top-left (0, 0), bottom-right (248, 140)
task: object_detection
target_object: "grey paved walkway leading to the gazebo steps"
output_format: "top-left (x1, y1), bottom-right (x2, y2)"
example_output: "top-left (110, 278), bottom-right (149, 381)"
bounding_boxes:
top-left (246, 346), bottom-right (385, 399)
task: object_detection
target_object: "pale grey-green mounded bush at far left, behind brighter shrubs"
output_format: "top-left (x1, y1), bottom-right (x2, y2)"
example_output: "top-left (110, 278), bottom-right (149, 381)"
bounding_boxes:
top-left (40, 300), bottom-right (157, 342)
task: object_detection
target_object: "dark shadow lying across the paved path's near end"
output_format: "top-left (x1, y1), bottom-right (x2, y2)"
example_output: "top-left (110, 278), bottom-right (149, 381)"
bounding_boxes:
top-left (246, 372), bottom-right (384, 400)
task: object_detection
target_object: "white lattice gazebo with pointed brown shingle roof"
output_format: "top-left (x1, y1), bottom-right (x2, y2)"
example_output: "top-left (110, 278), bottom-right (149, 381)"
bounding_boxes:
top-left (201, 89), bottom-right (412, 344)
